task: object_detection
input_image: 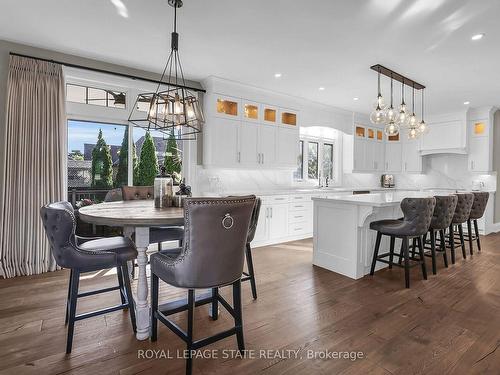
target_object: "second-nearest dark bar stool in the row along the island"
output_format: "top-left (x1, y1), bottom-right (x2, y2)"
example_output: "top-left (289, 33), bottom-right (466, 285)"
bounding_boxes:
top-left (424, 195), bottom-right (458, 275)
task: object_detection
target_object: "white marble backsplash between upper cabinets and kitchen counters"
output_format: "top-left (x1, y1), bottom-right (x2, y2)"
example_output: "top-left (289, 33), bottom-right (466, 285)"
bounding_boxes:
top-left (197, 154), bottom-right (496, 193)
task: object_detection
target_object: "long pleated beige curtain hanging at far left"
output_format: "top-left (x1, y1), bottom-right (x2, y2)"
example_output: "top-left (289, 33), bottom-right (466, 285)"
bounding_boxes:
top-left (0, 56), bottom-right (66, 277)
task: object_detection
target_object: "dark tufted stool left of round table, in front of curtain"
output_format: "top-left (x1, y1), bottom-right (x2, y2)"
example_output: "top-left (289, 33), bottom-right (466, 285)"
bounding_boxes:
top-left (40, 202), bottom-right (137, 353)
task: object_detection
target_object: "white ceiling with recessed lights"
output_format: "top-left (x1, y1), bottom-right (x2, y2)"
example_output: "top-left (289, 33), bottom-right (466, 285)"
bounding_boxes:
top-left (0, 0), bottom-right (500, 113)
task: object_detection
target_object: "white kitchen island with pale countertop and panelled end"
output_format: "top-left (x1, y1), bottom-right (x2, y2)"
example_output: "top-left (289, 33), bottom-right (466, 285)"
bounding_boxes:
top-left (312, 191), bottom-right (440, 279)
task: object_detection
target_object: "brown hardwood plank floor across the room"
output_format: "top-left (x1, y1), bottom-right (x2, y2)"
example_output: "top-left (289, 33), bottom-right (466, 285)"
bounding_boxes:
top-left (0, 235), bottom-right (500, 375)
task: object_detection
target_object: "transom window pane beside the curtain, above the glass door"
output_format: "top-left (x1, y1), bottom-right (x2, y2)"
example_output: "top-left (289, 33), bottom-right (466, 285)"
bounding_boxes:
top-left (66, 83), bottom-right (126, 108)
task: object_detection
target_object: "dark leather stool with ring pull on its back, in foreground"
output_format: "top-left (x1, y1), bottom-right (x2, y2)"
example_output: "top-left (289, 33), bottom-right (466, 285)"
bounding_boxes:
top-left (151, 195), bottom-right (255, 374)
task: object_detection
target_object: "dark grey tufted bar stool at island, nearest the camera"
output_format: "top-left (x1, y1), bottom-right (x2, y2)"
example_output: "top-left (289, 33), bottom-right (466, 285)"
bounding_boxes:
top-left (370, 197), bottom-right (436, 288)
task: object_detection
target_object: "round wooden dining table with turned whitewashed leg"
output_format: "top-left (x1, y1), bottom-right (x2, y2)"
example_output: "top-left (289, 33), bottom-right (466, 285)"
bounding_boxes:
top-left (78, 200), bottom-right (184, 340)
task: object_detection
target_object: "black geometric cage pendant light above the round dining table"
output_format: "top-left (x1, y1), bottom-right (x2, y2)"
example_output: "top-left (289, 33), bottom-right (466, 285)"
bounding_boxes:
top-left (128, 0), bottom-right (205, 140)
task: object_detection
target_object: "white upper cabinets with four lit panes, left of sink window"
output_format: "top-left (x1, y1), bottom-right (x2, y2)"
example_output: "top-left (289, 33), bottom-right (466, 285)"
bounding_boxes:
top-left (202, 93), bottom-right (299, 169)
